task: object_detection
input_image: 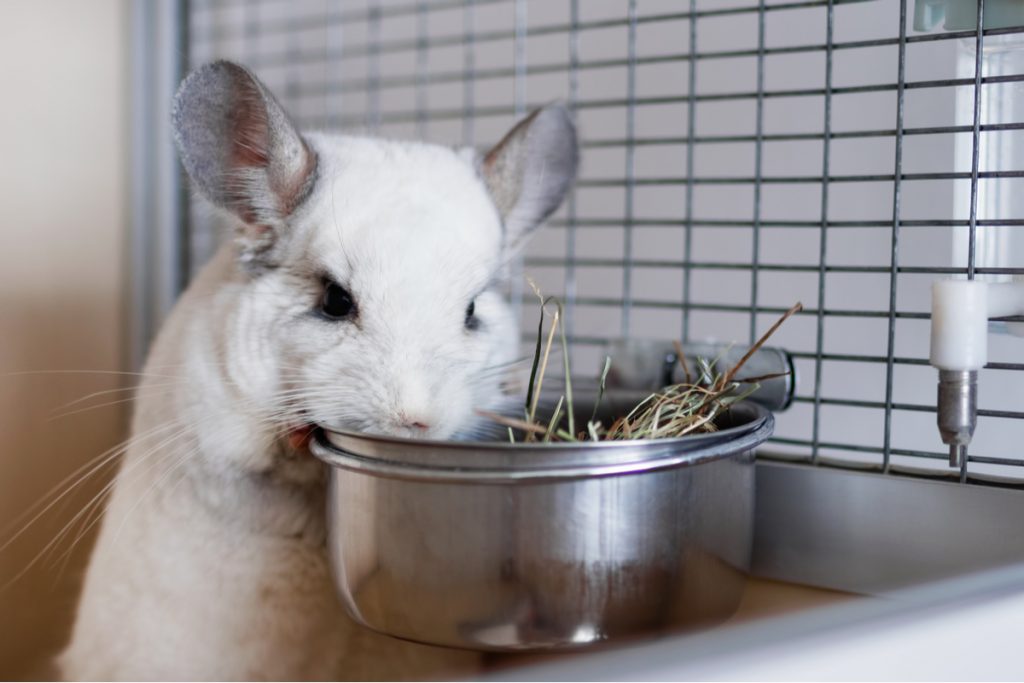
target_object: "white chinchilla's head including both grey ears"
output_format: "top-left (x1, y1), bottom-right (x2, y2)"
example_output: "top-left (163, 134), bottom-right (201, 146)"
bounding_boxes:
top-left (173, 61), bottom-right (578, 438)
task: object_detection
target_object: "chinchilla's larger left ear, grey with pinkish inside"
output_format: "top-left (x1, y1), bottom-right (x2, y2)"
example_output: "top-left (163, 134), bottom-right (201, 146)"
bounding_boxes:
top-left (171, 60), bottom-right (316, 259)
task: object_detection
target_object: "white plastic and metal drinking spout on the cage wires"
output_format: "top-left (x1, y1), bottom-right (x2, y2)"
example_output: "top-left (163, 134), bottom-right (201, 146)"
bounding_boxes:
top-left (931, 280), bottom-right (1024, 467)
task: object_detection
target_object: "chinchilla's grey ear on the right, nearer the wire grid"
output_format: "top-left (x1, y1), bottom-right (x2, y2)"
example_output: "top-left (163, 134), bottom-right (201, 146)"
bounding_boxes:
top-left (479, 104), bottom-right (580, 254)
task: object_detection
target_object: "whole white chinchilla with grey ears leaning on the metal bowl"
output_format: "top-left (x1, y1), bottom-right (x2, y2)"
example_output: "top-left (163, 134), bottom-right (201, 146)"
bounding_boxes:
top-left (59, 61), bottom-right (577, 680)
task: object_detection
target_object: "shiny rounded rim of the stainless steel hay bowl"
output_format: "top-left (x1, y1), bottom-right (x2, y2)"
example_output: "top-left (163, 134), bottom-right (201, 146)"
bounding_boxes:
top-left (310, 401), bottom-right (774, 483)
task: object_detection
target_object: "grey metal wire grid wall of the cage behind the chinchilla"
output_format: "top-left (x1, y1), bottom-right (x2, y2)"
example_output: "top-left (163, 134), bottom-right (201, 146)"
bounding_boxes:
top-left (190, 0), bottom-right (1024, 480)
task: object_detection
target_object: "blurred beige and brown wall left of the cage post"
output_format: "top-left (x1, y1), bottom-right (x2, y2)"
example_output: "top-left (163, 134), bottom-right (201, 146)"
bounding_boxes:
top-left (0, 0), bottom-right (127, 678)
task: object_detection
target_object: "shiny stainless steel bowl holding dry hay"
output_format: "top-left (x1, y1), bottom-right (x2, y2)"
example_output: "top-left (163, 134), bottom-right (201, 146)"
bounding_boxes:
top-left (313, 403), bottom-right (774, 650)
